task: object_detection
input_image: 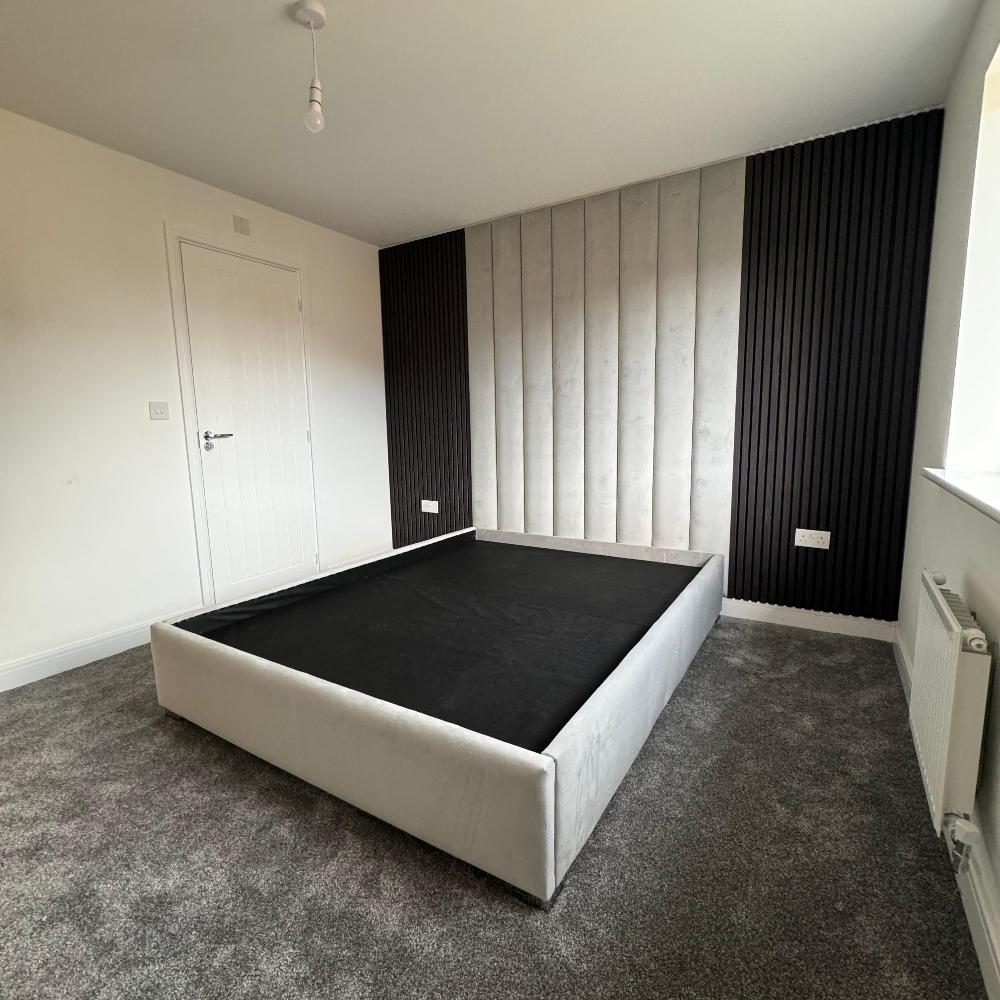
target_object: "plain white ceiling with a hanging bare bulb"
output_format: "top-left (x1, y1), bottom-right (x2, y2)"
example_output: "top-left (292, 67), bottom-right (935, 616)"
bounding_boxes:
top-left (0, 0), bottom-right (978, 246)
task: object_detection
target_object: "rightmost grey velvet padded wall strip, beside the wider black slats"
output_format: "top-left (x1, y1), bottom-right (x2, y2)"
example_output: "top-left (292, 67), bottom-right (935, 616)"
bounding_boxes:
top-left (690, 160), bottom-right (746, 554)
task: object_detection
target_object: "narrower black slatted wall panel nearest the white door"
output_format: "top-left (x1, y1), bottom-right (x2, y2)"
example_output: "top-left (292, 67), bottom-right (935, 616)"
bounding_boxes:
top-left (379, 230), bottom-right (472, 548)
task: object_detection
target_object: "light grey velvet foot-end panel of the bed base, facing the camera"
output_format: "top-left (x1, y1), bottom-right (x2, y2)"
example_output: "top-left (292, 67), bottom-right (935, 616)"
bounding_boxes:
top-left (151, 625), bottom-right (555, 900)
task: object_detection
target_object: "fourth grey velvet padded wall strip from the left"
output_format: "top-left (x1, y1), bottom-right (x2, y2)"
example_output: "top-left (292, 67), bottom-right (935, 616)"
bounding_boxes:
top-left (548, 201), bottom-right (584, 538)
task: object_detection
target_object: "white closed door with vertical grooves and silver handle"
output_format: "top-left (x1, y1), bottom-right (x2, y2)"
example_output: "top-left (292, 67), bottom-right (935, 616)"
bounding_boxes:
top-left (181, 243), bottom-right (319, 603)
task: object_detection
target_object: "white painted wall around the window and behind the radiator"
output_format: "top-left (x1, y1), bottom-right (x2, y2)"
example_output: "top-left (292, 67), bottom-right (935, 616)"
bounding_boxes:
top-left (899, 0), bottom-right (1000, 866)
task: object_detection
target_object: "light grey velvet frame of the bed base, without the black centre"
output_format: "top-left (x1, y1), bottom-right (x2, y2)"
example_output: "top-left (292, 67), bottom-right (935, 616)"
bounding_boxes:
top-left (151, 530), bottom-right (723, 903)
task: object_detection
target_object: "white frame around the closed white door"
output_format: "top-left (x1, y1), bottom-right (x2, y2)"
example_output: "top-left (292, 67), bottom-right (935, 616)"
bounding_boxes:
top-left (163, 220), bottom-right (322, 608)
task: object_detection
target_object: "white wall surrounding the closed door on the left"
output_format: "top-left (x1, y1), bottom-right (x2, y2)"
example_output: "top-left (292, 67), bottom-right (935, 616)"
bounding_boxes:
top-left (0, 111), bottom-right (391, 672)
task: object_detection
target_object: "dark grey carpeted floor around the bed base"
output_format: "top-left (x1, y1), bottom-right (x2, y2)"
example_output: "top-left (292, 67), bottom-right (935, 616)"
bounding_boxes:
top-left (0, 619), bottom-right (985, 1000)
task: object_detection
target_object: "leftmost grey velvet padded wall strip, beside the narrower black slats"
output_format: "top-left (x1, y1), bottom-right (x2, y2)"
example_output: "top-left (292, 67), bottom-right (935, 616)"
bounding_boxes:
top-left (465, 223), bottom-right (497, 528)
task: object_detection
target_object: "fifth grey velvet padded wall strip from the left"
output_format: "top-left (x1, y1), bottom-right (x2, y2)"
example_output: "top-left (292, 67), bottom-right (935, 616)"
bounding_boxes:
top-left (583, 191), bottom-right (619, 542)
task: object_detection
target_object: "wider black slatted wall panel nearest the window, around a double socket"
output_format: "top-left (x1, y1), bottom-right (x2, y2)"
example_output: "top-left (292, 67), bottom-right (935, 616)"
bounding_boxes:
top-left (729, 111), bottom-right (943, 621)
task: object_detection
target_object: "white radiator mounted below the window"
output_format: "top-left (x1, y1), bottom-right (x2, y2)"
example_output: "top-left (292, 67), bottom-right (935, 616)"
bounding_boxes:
top-left (910, 570), bottom-right (991, 834)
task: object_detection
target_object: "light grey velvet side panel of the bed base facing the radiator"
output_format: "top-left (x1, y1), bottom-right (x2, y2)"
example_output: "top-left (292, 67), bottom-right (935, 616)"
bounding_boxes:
top-left (544, 556), bottom-right (723, 885)
